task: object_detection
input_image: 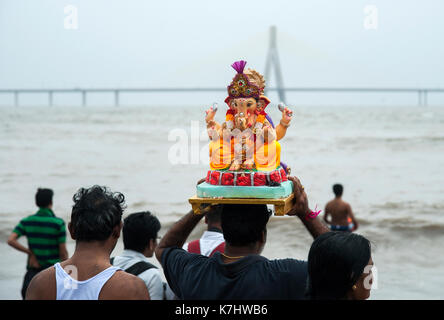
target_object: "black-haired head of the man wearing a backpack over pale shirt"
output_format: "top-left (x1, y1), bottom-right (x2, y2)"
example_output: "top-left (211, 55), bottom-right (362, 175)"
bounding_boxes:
top-left (122, 211), bottom-right (160, 252)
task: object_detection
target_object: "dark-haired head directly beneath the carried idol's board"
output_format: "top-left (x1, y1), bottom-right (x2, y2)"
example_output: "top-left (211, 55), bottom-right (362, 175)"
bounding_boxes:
top-left (221, 204), bottom-right (271, 247)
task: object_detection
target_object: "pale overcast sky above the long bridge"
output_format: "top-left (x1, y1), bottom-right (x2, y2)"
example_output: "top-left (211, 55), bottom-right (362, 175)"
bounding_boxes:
top-left (0, 0), bottom-right (444, 106)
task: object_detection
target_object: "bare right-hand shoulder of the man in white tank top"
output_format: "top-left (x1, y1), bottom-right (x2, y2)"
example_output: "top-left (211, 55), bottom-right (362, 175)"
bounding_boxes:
top-left (99, 271), bottom-right (149, 300)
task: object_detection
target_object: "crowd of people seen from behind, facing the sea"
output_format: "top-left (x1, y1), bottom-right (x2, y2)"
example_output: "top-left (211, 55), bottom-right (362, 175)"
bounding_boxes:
top-left (8, 177), bottom-right (373, 300)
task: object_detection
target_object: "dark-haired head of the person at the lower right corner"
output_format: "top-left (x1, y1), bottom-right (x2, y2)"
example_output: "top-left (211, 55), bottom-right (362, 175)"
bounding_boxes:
top-left (308, 231), bottom-right (371, 300)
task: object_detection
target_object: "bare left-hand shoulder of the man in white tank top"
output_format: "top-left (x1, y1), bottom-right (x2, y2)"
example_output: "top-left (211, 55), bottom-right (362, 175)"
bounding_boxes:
top-left (26, 267), bottom-right (57, 300)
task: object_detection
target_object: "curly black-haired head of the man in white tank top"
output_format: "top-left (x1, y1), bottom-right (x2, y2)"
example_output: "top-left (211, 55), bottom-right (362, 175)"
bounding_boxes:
top-left (71, 185), bottom-right (125, 241)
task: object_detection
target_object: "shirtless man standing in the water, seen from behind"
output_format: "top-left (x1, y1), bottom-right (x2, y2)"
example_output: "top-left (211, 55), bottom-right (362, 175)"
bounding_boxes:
top-left (324, 184), bottom-right (358, 232)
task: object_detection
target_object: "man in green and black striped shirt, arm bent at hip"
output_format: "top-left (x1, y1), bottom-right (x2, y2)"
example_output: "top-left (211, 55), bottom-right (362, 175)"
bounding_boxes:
top-left (8, 189), bottom-right (68, 299)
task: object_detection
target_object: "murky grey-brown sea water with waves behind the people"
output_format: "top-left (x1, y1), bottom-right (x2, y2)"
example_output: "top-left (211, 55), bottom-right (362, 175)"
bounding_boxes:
top-left (0, 105), bottom-right (444, 299)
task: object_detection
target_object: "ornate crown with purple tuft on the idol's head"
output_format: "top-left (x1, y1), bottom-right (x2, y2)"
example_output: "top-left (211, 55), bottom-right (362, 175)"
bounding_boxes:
top-left (227, 60), bottom-right (261, 99)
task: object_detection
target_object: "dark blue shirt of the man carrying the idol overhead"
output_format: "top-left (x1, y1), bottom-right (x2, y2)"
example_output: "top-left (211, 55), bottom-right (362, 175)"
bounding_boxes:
top-left (162, 247), bottom-right (307, 300)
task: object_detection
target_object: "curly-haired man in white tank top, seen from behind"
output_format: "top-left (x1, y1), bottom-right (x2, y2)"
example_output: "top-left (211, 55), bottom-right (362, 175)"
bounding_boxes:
top-left (26, 186), bottom-right (149, 300)
